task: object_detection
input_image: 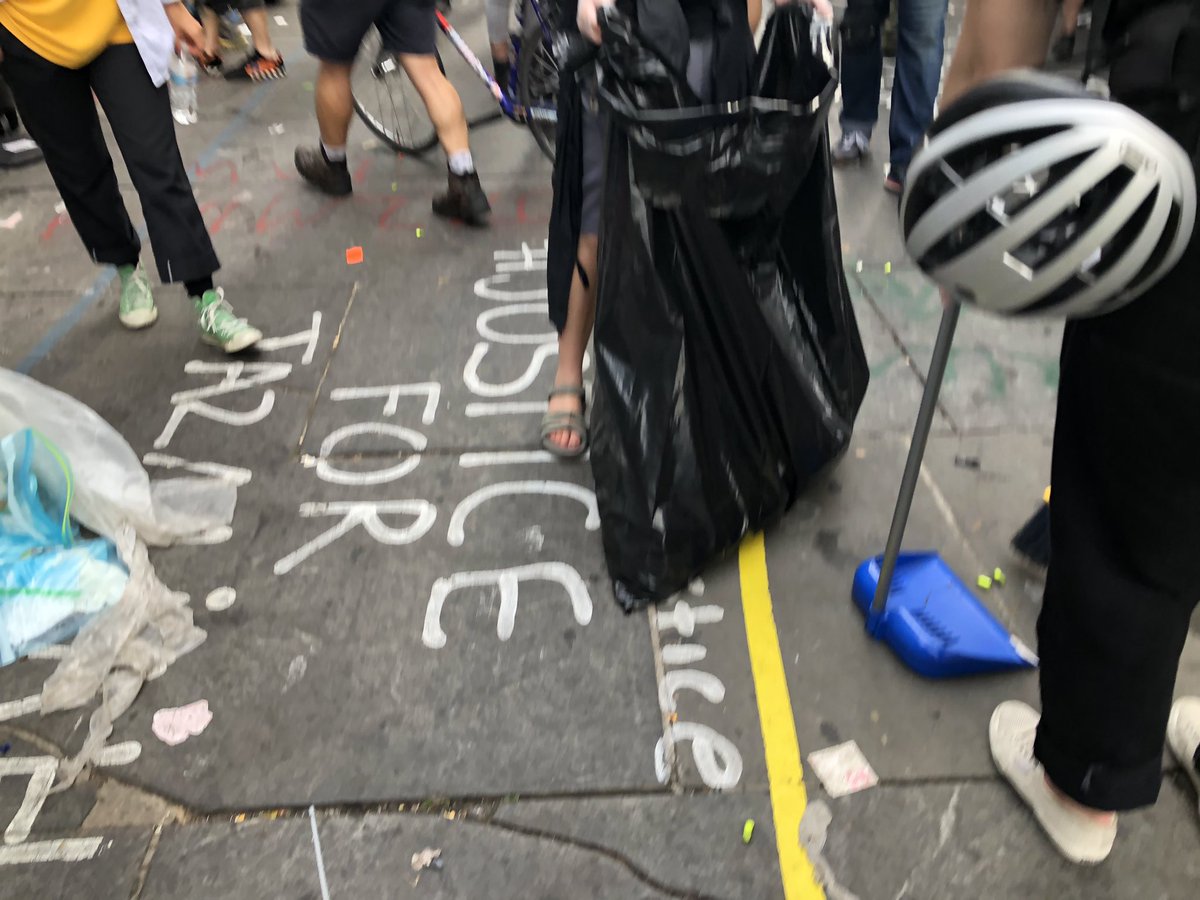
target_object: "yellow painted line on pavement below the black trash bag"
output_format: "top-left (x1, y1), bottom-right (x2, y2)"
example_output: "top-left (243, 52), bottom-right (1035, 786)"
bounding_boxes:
top-left (738, 534), bottom-right (824, 900)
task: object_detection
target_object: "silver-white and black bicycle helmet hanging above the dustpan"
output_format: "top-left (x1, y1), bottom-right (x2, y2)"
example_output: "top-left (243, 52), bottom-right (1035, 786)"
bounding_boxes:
top-left (900, 72), bottom-right (1196, 317)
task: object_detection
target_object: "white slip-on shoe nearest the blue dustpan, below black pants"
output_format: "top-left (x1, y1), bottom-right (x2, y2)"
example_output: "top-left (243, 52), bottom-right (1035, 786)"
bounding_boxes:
top-left (988, 700), bottom-right (1117, 865)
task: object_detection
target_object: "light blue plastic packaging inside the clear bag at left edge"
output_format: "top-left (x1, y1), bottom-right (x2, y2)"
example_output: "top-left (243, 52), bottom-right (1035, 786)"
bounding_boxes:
top-left (0, 430), bottom-right (128, 666)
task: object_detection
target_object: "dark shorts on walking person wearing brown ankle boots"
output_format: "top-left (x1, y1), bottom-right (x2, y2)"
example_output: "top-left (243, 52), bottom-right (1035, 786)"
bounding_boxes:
top-left (300, 0), bottom-right (438, 62)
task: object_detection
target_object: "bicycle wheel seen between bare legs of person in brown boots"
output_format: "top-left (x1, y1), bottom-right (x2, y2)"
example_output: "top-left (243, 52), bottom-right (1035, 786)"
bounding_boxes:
top-left (353, 28), bottom-right (445, 156)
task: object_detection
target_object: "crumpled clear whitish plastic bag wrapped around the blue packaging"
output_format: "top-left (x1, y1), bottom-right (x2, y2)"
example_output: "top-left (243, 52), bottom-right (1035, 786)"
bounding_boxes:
top-left (0, 368), bottom-right (238, 790)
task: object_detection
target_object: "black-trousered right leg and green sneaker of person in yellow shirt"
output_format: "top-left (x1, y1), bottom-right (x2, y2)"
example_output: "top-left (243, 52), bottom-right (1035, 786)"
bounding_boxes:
top-left (85, 44), bottom-right (263, 353)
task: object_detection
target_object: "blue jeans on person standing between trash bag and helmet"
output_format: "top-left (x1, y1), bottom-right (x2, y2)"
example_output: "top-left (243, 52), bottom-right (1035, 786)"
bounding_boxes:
top-left (841, 0), bottom-right (948, 168)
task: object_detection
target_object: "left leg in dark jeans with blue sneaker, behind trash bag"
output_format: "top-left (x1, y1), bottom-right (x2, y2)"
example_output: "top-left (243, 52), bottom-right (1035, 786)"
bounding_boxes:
top-left (834, 0), bottom-right (888, 162)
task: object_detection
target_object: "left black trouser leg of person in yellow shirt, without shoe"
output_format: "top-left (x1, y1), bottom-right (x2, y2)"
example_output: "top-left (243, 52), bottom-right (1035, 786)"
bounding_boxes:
top-left (0, 26), bottom-right (141, 274)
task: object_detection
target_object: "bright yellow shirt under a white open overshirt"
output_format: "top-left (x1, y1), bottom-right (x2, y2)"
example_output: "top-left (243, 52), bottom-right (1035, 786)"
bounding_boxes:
top-left (0, 0), bottom-right (133, 68)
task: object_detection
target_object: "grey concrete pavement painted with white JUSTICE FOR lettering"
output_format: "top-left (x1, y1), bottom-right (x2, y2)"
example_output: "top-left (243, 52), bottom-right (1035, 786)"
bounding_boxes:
top-left (0, 0), bottom-right (1200, 900)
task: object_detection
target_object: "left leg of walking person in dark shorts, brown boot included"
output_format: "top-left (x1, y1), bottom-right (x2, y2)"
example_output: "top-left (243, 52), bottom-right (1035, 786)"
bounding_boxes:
top-left (295, 0), bottom-right (383, 196)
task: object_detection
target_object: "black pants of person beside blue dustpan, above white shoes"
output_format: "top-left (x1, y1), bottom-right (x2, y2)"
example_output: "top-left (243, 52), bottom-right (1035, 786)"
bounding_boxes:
top-left (1034, 111), bottom-right (1200, 810)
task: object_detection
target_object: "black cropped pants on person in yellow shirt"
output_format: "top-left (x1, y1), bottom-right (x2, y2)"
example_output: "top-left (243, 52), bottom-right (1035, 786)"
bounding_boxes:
top-left (0, 26), bottom-right (221, 282)
